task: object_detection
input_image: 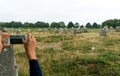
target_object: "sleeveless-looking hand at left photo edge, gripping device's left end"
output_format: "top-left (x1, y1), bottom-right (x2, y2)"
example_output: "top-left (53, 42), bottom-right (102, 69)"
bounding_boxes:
top-left (0, 32), bottom-right (12, 53)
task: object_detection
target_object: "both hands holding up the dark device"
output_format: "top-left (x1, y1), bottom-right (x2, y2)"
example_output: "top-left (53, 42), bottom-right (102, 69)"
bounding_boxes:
top-left (0, 33), bottom-right (37, 60)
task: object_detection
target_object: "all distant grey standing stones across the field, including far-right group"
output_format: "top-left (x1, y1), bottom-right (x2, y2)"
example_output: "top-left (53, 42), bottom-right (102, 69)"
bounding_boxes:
top-left (3, 26), bottom-right (120, 37)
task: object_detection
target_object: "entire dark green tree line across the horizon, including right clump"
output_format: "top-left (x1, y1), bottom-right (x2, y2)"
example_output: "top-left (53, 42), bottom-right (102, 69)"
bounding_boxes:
top-left (0, 19), bottom-right (120, 28)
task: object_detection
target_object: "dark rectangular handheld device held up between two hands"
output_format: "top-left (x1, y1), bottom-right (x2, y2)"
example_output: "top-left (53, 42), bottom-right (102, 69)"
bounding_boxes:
top-left (9, 35), bottom-right (27, 44)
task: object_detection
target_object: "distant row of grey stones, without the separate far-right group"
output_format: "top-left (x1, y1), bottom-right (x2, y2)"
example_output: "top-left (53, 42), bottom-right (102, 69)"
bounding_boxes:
top-left (7, 27), bottom-right (88, 35)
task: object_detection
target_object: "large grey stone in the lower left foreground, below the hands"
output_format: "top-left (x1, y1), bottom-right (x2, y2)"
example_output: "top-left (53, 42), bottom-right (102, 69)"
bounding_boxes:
top-left (0, 30), bottom-right (18, 76)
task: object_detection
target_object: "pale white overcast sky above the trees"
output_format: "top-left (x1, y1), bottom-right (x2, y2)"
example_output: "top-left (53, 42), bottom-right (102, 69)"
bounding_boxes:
top-left (0, 0), bottom-right (120, 25)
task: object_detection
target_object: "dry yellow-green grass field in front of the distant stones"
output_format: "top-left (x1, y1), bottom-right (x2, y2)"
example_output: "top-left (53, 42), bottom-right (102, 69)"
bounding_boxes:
top-left (8, 29), bottom-right (120, 76)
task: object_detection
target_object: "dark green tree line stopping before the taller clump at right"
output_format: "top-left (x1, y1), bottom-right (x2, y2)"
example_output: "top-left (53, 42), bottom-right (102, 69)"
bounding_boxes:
top-left (0, 21), bottom-right (99, 28)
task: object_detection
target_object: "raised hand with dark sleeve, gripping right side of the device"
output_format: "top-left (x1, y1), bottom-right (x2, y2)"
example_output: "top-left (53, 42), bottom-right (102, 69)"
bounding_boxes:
top-left (23, 33), bottom-right (37, 60)
